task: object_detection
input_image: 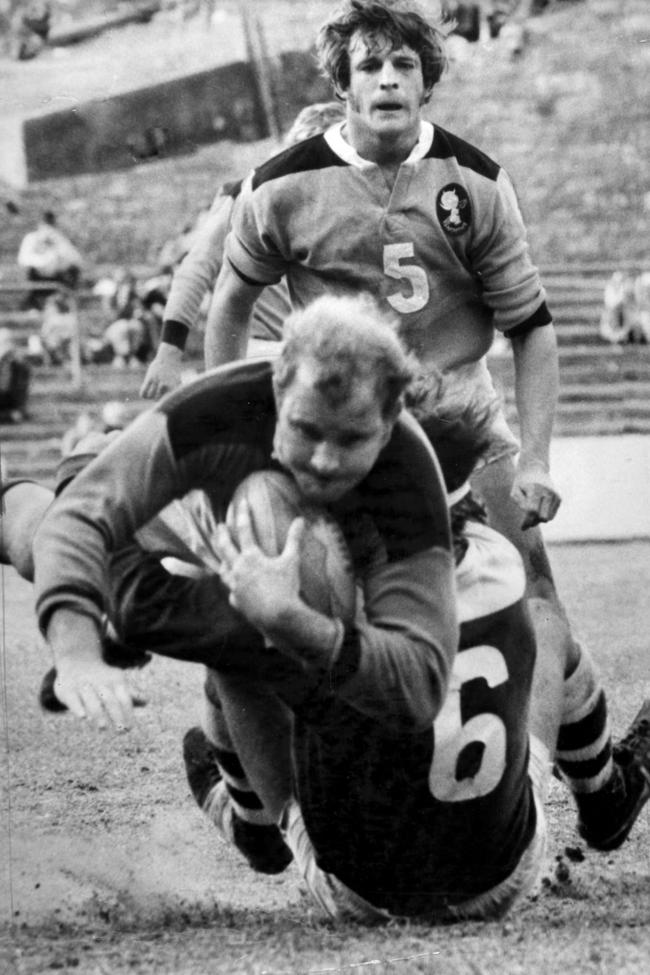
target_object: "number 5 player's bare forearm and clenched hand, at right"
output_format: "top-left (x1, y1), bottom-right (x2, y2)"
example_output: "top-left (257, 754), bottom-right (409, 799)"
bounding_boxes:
top-left (511, 324), bottom-right (560, 528)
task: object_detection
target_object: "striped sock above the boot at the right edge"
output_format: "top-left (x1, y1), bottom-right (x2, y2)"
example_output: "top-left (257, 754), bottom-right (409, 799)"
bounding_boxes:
top-left (555, 647), bottom-right (614, 807)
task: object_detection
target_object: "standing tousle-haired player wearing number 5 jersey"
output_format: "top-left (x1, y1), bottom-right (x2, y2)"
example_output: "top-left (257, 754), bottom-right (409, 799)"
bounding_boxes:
top-left (201, 0), bottom-right (608, 776)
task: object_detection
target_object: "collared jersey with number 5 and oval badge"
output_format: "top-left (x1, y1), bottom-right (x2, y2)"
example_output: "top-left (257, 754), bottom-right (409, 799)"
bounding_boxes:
top-left (225, 122), bottom-right (551, 369)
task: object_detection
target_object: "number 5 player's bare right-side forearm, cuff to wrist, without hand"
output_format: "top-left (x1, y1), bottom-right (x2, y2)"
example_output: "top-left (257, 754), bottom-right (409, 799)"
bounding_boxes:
top-left (512, 325), bottom-right (559, 470)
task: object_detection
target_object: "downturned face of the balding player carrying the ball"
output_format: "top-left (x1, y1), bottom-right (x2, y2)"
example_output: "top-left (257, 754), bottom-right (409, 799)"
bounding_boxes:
top-left (275, 363), bottom-right (393, 504)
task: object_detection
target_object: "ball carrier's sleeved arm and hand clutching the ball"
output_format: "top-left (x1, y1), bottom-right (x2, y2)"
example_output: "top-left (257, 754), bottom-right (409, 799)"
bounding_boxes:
top-left (215, 496), bottom-right (458, 732)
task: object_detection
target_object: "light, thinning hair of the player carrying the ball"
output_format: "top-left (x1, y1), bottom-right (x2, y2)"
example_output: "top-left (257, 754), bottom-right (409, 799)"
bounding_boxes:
top-left (273, 294), bottom-right (416, 418)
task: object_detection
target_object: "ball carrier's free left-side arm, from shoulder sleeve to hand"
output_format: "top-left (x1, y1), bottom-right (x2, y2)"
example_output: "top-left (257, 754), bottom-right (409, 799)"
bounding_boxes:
top-left (32, 411), bottom-right (197, 727)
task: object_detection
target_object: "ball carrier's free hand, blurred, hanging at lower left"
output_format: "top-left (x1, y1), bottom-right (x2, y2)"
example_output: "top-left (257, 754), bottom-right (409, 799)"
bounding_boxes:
top-left (54, 657), bottom-right (134, 731)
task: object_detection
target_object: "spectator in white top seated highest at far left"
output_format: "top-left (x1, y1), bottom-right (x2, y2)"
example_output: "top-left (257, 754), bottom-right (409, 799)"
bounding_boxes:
top-left (17, 210), bottom-right (83, 308)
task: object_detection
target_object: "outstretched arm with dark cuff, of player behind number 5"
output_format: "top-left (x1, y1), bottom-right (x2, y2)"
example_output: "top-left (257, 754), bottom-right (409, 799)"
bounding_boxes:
top-left (140, 195), bottom-right (234, 399)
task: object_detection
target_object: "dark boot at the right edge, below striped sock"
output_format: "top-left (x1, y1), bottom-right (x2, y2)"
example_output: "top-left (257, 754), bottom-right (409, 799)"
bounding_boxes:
top-left (578, 699), bottom-right (650, 850)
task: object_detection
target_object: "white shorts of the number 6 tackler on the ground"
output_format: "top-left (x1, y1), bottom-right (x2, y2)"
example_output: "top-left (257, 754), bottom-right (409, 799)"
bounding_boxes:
top-left (282, 735), bottom-right (552, 924)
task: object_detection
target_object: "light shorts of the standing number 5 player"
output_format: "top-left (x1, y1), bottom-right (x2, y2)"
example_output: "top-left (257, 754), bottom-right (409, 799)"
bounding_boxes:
top-left (407, 357), bottom-right (519, 470)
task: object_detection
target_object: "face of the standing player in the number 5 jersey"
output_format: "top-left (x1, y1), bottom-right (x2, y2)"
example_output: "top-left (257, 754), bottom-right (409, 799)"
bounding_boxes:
top-left (344, 34), bottom-right (425, 155)
